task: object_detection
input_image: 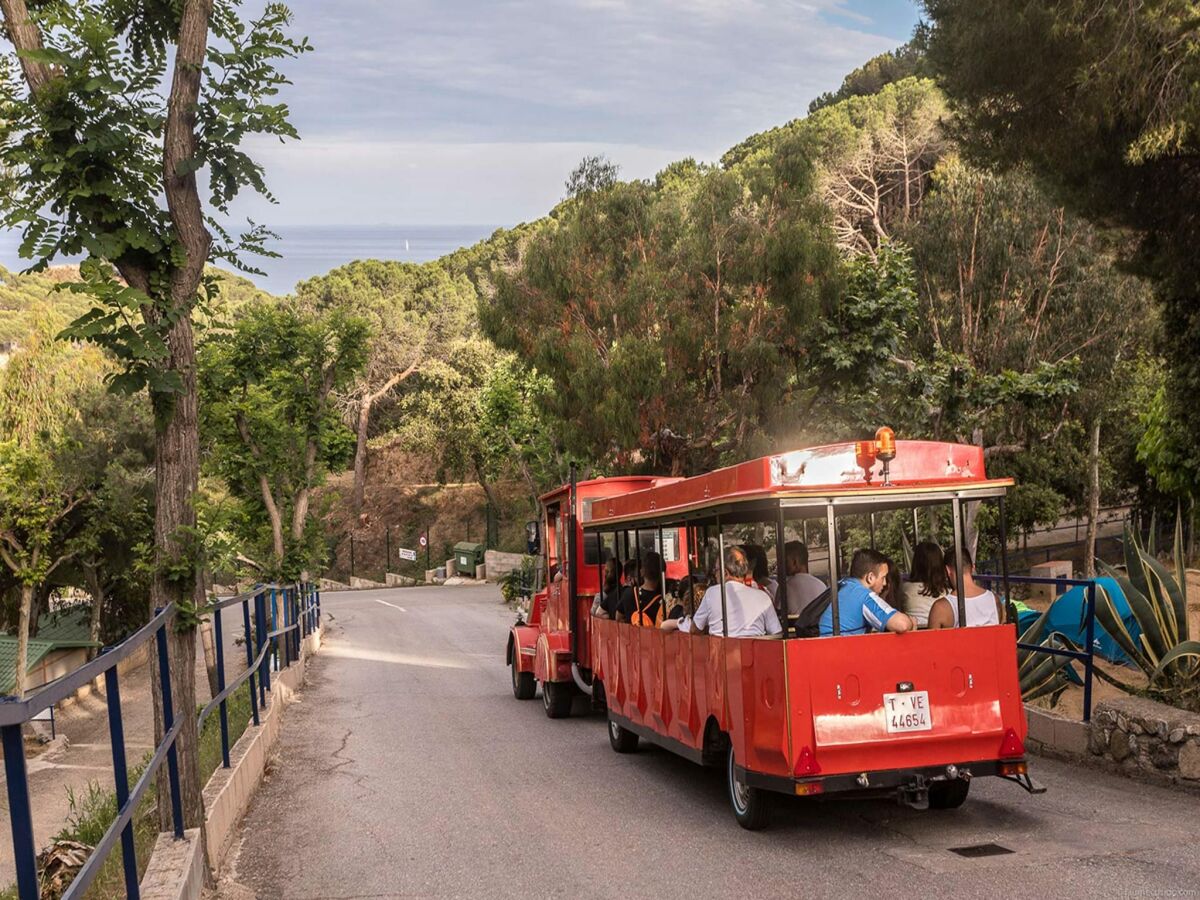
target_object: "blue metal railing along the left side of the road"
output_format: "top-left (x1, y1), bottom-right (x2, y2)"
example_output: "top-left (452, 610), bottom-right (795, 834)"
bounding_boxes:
top-left (0, 583), bottom-right (320, 900)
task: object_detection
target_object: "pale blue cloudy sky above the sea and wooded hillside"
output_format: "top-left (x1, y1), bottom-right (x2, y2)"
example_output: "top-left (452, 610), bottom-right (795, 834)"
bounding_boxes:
top-left (238, 0), bottom-right (918, 227)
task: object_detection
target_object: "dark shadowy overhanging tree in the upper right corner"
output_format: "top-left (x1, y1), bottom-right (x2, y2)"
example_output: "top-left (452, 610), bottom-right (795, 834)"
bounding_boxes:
top-left (925, 0), bottom-right (1200, 494)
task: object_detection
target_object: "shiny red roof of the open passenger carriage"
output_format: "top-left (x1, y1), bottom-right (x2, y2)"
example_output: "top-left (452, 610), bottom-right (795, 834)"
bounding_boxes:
top-left (583, 440), bottom-right (1013, 530)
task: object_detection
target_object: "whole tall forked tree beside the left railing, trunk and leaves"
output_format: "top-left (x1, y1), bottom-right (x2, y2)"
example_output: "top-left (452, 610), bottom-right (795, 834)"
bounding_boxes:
top-left (0, 0), bottom-right (306, 828)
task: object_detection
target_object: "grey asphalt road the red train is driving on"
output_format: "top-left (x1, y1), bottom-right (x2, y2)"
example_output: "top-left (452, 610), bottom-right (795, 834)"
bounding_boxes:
top-left (230, 587), bottom-right (1200, 900)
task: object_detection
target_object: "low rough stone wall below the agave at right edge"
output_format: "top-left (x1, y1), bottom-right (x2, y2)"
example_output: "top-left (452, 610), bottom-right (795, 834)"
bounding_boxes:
top-left (1087, 697), bottom-right (1200, 787)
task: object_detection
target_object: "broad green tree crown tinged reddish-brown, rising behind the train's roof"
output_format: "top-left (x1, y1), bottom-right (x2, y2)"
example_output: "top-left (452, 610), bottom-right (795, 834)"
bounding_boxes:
top-left (481, 142), bottom-right (838, 473)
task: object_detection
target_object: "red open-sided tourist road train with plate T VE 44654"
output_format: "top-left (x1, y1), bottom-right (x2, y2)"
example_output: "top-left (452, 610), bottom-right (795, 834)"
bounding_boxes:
top-left (508, 428), bottom-right (1040, 828)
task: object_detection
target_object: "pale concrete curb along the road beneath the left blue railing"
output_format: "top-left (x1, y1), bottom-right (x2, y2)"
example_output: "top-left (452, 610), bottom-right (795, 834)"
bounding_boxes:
top-left (142, 629), bottom-right (322, 900)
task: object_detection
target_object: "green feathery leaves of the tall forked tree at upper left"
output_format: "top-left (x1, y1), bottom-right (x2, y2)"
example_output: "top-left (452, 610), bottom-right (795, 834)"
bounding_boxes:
top-left (0, 0), bottom-right (308, 400)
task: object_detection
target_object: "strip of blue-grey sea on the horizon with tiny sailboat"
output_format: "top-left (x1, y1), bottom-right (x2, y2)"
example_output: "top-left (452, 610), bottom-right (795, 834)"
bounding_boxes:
top-left (0, 224), bottom-right (498, 294)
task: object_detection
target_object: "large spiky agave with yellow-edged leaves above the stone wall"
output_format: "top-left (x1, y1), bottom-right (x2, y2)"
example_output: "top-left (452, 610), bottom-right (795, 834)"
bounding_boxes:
top-left (1096, 516), bottom-right (1200, 707)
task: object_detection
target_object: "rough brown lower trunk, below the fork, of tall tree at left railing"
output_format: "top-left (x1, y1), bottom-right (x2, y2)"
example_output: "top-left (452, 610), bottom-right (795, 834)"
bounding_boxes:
top-left (150, 312), bottom-right (204, 832)
